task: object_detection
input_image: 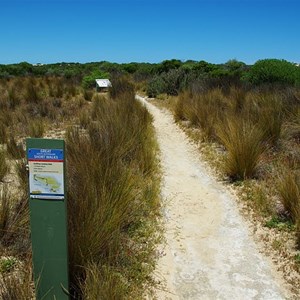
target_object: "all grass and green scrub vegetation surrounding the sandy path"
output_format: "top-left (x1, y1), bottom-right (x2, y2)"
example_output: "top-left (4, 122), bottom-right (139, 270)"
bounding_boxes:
top-left (0, 59), bottom-right (300, 299)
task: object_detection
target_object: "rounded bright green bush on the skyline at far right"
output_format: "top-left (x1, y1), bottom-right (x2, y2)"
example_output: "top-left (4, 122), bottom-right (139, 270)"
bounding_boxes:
top-left (246, 59), bottom-right (300, 85)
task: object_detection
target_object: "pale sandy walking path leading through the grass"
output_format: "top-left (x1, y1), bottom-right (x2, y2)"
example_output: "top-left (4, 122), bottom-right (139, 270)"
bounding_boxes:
top-left (137, 96), bottom-right (285, 300)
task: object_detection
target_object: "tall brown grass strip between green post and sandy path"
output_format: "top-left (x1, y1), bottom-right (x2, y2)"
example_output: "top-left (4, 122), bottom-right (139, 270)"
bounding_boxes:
top-left (67, 81), bottom-right (159, 299)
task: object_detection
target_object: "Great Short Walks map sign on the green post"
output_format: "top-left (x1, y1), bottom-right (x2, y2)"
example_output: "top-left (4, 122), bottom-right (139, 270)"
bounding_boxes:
top-left (28, 149), bottom-right (64, 199)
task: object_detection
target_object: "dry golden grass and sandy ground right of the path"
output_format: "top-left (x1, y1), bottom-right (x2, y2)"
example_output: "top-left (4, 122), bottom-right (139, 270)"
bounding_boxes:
top-left (157, 86), bottom-right (300, 299)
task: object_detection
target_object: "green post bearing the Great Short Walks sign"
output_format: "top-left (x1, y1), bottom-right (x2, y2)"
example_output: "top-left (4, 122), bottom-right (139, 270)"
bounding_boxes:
top-left (26, 139), bottom-right (69, 300)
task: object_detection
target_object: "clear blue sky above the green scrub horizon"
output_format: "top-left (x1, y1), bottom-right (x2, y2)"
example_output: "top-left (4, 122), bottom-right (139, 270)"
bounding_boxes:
top-left (0, 0), bottom-right (300, 64)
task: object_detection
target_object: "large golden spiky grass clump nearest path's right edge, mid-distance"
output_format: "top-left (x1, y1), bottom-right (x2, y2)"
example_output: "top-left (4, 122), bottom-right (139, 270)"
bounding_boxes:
top-left (217, 117), bottom-right (266, 180)
